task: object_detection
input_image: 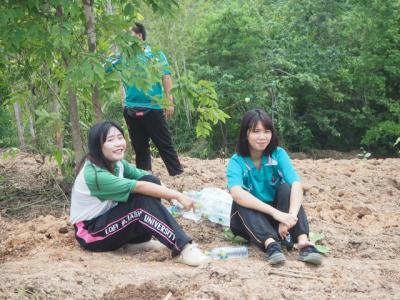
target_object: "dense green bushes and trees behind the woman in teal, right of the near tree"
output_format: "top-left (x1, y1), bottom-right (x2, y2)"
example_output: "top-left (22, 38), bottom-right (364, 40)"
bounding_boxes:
top-left (147, 0), bottom-right (400, 156)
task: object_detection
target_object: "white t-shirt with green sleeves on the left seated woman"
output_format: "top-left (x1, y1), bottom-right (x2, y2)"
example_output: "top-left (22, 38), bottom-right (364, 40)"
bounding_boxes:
top-left (70, 160), bottom-right (148, 224)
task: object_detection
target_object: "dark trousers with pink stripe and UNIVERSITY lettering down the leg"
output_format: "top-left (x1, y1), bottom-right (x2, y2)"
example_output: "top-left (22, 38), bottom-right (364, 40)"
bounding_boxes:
top-left (74, 175), bottom-right (192, 256)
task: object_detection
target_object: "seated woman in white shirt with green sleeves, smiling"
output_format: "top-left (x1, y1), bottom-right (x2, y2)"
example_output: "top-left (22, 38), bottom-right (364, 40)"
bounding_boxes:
top-left (70, 122), bottom-right (210, 266)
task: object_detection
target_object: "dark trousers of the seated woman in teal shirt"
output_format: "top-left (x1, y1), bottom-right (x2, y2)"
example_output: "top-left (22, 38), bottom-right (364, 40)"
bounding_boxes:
top-left (230, 183), bottom-right (309, 251)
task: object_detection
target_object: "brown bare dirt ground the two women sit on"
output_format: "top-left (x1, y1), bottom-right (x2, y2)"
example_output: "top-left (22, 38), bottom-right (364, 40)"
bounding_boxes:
top-left (0, 154), bottom-right (400, 299)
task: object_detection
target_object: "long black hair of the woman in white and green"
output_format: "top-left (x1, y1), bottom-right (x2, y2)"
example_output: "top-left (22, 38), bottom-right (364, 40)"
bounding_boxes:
top-left (78, 121), bottom-right (125, 173)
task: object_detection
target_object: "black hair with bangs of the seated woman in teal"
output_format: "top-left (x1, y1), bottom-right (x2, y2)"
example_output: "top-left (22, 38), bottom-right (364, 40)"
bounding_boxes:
top-left (236, 109), bottom-right (279, 157)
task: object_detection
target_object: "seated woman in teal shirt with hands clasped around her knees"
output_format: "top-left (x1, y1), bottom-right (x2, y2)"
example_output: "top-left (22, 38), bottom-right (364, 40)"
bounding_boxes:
top-left (227, 109), bottom-right (322, 265)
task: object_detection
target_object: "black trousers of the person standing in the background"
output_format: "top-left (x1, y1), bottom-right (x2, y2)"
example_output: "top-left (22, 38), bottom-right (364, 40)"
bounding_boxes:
top-left (124, 107), bottom-right (183, 176)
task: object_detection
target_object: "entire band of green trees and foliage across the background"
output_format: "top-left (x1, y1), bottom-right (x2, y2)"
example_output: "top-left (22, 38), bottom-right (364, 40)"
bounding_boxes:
top-left (0, 0), bottom-right (400, 162)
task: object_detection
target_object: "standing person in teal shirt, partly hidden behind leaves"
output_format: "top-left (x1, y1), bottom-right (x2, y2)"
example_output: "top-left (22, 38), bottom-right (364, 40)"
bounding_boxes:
top-left (107, 23), bottom-right (183, 176)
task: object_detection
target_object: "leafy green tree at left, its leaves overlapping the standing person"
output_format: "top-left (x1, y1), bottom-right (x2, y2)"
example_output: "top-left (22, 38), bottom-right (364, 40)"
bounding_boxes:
top-left (0, 0), bottom-right (176, 166)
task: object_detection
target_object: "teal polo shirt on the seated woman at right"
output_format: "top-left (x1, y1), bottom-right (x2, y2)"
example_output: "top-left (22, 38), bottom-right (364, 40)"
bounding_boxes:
top-left (226, 147), bottom-right (300, 203)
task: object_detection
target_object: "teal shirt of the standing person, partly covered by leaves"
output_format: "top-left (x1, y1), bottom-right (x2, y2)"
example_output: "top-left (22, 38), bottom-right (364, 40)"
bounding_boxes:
top-left (106, 46), bottom-right (171, 109)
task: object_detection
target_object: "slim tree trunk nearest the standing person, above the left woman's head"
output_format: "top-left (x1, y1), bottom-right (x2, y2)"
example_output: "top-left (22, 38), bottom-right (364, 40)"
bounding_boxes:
top-left (82, 0), bottom-right (103, 122)
